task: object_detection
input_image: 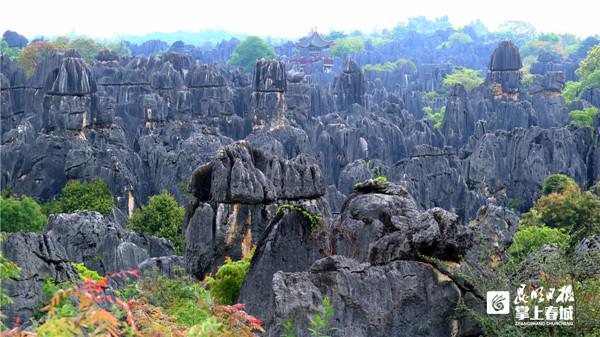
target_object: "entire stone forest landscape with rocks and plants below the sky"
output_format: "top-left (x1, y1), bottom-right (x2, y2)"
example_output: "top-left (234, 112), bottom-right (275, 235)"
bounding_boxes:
top-left (0, 11), bottom-right (600, 337)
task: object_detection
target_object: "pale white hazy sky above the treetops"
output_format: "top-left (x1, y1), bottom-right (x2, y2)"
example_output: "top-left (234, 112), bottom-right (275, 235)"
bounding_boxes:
top-left (0, 0), bottom-right (600, 38)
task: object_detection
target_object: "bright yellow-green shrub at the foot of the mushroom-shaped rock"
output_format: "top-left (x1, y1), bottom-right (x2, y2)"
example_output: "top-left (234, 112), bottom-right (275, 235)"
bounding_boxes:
top-left (206, 249), bottom-right (254, 305)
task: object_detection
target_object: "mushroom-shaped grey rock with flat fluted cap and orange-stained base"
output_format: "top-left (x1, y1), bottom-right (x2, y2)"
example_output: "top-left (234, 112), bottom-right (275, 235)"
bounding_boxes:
top-left (184, 141), bottom-right (329, 277)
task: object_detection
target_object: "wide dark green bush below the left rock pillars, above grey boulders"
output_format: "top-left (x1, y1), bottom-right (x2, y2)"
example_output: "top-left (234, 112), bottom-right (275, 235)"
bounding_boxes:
top-left (54, 177), bottom-right (115, 215)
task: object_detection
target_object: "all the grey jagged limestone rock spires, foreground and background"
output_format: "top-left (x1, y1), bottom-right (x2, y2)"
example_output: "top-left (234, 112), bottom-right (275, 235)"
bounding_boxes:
top-left (0, 38), bottom-right (600, 336)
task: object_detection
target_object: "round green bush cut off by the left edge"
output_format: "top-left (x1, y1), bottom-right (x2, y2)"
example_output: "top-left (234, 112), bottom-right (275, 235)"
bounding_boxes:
top-left (0, 196), bottom-right (48, 233)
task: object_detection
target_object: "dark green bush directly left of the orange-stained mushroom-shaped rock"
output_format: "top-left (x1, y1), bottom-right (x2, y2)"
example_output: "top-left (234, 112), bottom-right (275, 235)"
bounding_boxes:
top-left (128, 191), bottom-right (185, 254)
